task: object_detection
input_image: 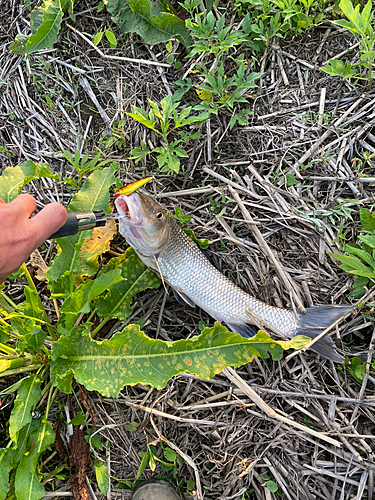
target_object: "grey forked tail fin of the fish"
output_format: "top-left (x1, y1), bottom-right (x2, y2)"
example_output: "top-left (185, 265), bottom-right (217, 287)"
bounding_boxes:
top-left (295, 306), bottom-right (354, 363)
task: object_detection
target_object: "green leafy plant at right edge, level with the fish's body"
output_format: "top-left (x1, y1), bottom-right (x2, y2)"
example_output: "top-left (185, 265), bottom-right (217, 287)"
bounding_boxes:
top-left (330, 208), bottom-right (375, 298)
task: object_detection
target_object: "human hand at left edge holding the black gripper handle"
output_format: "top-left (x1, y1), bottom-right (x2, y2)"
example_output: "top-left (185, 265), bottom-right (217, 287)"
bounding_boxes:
top-left (0, 194), bottom-right (67, 283)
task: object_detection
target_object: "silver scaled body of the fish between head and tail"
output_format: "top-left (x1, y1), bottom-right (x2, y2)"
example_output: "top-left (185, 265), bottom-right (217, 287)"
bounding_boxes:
top-left (155, 218), bottom-right (298, 337)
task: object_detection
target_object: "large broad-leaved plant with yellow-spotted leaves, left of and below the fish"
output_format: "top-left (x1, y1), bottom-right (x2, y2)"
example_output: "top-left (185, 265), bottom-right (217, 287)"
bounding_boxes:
top-left (0, 161), bottom-right (308, 500)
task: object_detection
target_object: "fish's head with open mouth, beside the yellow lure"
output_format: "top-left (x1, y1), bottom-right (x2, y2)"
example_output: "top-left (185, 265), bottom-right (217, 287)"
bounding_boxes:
top-left (115, 192), bottom-right (170, 265)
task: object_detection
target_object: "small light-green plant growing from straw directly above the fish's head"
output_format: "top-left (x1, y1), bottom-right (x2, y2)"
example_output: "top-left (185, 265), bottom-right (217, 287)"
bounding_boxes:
top-left (127, 95), bottom-right (209, 174)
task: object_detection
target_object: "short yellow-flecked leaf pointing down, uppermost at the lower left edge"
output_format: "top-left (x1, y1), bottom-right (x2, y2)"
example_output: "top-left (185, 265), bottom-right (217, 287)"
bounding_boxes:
top-left (9, 375), bottom-right (42, 442)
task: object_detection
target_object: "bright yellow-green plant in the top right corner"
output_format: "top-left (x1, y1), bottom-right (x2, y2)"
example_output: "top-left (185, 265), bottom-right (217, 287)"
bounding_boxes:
top-left (320, 0), bottom-right (375, 82)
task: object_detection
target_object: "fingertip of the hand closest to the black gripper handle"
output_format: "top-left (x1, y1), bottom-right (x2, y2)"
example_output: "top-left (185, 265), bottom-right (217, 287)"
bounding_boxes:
top-left (29, 203), bottom-right (68, 247)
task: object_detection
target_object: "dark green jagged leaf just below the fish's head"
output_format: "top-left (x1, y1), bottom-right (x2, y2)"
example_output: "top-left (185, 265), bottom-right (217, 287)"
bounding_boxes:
top-left (96, 248), bottom-right (160, 320)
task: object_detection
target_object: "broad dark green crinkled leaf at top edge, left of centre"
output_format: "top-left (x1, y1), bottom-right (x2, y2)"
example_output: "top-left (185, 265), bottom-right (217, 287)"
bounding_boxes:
top-left (107, 0), bottom-right (191, 46)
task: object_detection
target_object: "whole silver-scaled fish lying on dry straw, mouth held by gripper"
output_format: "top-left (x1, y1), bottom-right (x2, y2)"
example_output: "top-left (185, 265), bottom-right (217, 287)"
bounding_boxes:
top-left (115, 189), bottom-right (353, 363)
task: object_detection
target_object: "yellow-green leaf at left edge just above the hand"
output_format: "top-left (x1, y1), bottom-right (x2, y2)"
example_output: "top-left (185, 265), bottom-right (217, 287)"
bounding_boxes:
top-left (0, 160), bottom-right (59, 203)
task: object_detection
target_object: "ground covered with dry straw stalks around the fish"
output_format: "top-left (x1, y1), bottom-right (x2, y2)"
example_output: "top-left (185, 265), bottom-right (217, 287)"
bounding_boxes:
top-left (0, 0), bottom-right (375, 500)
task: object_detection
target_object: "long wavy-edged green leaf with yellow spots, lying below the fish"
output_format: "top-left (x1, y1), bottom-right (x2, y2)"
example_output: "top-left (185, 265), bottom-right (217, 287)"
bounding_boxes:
top-left (51, 323), bottom-right (310, 397)
